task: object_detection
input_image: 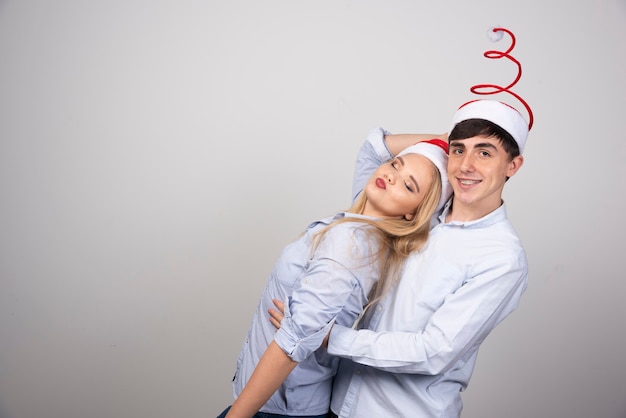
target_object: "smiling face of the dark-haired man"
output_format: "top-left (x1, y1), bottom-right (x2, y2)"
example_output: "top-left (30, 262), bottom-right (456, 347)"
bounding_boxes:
top-left (448, 136), bottom-right (524, 219)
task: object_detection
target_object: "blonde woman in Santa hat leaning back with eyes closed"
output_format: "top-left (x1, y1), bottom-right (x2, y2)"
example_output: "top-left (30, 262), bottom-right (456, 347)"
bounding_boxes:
top-left (220, 130), bottom-right (450, 418)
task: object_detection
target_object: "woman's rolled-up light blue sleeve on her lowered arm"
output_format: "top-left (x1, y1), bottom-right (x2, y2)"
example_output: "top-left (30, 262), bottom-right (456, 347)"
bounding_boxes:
top-left (274, 223), bottom-right (377, 362)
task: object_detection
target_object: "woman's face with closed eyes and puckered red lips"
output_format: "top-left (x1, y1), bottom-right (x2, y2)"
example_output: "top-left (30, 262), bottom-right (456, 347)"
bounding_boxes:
top-left (363, 154), bottom-right (435, 219)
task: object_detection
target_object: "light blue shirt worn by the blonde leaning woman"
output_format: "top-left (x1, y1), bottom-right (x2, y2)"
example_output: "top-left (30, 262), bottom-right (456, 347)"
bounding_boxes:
top-left (233, 213), bottom-right (378, 415)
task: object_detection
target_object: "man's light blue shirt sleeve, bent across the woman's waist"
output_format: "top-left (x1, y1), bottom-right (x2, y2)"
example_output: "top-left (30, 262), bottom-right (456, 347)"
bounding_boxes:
top-left (328, 251), bottom-right (527, 375)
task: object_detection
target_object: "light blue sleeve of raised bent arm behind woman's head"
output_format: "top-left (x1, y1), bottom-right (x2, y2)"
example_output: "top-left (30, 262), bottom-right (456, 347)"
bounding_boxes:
top-left (352, 128), bottom-right (393, 202)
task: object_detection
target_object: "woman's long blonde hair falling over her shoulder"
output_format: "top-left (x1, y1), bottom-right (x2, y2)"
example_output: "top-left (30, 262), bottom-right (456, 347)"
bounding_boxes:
top-left (312, 163), bottom-right (442, 309)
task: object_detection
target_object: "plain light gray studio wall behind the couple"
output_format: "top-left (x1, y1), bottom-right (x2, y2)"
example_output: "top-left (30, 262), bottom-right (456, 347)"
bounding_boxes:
top-left (0, 0), bottom-right (626, 418)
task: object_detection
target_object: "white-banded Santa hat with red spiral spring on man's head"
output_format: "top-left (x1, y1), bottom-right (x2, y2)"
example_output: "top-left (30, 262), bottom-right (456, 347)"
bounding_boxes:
top-left (449, 27), bottom-right (534, 154)
